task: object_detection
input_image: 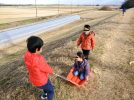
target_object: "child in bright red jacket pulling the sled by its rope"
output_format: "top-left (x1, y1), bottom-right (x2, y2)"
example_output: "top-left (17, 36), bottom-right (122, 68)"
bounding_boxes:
top-left (24, 36), bottom-right (54, 100)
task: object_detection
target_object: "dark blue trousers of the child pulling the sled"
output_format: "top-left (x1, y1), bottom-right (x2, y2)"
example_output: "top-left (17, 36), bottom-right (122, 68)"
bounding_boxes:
top-left (38, 80), bottom-right (54, 100)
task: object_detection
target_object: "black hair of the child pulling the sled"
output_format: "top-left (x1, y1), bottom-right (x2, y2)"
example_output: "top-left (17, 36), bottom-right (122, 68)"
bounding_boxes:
top-left (27, 36), bottom-right (43, 53)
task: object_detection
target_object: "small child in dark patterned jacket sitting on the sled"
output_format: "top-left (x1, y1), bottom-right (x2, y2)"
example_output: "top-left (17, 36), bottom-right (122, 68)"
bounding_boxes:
top-left (73, 51), bottom-right (90, 80)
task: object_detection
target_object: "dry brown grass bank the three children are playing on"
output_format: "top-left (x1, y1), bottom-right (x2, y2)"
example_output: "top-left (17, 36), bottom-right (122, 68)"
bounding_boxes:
top-left (0, 9), bottom-right (134, 100)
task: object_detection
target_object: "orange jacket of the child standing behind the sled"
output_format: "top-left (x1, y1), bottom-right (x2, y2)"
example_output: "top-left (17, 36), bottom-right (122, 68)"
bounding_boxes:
top-left (77, 32), bottom-right (95, 50)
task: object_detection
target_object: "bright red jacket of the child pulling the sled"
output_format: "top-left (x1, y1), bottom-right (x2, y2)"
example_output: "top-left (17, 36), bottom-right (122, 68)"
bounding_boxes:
top-left (24, 51), bottom-right (53, 86)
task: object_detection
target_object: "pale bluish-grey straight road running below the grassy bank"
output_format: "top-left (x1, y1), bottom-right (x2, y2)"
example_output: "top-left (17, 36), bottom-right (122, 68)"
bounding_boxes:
top-left (0, 15), bottom-right (80, 45)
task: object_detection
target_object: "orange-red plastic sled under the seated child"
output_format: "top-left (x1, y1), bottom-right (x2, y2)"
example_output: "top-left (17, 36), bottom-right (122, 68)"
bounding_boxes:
top-left (67, 69), bottom-right (86, 87)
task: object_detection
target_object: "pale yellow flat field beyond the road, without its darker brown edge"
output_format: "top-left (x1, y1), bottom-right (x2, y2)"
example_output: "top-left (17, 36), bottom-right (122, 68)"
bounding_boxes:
top-left (0, 7), bottom-right (93, 24)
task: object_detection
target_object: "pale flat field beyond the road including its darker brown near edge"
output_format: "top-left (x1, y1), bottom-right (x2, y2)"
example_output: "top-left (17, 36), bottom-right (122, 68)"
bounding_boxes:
top-left (0, 6), bottom-right (97, 30)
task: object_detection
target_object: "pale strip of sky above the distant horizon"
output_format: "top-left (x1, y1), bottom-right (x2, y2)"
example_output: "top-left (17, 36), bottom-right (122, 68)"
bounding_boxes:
top-left (0, 0), bottom-right (124, 5)
